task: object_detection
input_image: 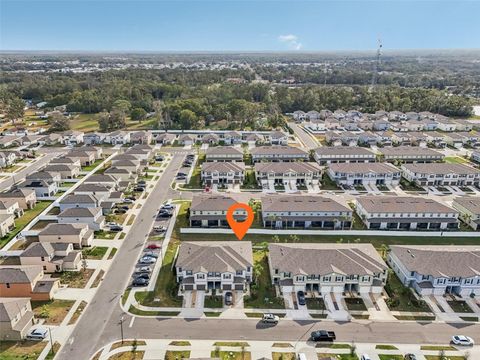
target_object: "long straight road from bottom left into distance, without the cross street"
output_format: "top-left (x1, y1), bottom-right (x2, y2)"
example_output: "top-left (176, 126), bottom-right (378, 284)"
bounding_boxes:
top-left (56, 154), bottom-right (185, 360)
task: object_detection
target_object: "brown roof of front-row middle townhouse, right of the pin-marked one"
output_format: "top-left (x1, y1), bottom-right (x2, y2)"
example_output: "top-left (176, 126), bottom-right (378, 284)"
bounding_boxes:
top-left (268, 243), bottom-right (387, 275)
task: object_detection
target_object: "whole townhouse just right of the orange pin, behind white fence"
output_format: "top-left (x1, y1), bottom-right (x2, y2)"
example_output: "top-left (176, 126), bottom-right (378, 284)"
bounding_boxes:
top-left (262, 195), bottom-right (353, 229)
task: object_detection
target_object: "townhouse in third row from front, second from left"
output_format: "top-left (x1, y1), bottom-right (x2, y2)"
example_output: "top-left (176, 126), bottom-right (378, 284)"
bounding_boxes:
top-left (254, 161), bottom-right (322, 186)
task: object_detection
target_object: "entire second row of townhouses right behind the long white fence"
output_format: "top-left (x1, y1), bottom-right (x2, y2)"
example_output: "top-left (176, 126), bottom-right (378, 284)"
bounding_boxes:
top-left (189, 194), bottom-right (480, 231)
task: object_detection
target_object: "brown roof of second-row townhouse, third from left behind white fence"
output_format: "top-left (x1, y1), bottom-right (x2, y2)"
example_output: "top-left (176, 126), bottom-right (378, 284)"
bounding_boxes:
top-left (357, 196), bottom-right (456, 213)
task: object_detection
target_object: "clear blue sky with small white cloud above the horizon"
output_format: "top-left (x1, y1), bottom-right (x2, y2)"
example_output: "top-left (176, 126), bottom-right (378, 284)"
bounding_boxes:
top-left (0, 0), bottom-right (480, 51)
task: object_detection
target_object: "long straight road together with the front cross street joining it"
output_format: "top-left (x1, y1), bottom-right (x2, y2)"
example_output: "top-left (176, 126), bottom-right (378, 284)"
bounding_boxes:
top-left (56, 152), bottom-right (480, 360)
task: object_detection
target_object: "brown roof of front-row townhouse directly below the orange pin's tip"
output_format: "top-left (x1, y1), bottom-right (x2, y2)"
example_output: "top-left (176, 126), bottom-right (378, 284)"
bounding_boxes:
top-left (176, 241), bottom-right (253, 273)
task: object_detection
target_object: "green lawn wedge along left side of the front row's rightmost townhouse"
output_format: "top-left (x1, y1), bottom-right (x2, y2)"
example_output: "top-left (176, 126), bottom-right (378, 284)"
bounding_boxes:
top-left (385, 272), bottom-right (431, 312)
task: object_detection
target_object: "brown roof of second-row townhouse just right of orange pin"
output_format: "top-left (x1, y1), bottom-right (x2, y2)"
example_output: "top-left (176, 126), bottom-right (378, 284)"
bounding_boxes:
top-left (262, 195), bottom-right (352, 213)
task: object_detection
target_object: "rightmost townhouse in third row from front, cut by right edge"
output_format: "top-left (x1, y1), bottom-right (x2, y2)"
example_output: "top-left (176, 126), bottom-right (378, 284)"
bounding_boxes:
top-left (402, 163), bottom-right (480, 186)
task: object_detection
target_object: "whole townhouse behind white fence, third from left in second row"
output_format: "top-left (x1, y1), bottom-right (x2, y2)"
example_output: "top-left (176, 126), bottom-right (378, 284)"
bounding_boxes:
top-left (356, 196), bottom-right (459, 230)
